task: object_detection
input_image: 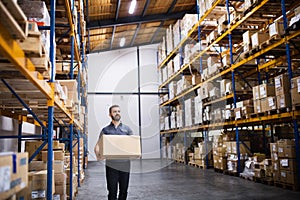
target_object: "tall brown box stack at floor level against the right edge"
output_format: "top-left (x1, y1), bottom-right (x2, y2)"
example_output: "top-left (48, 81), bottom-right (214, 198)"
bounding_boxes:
top-left (270, 139), bottom-right (299, 189)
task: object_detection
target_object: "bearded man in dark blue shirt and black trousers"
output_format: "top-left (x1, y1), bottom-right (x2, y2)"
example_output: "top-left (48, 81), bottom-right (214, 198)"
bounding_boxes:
top-left (100, 105), bottom-right (133, 200)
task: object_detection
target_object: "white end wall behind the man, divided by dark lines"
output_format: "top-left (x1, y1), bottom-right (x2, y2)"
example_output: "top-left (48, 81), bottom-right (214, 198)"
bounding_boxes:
top-left (88, 45), bottom-right (160, 160)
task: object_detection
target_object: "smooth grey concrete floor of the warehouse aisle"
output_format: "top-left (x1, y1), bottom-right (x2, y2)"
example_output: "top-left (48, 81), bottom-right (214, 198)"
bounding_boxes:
top-left (76, 160), bottom-right (300, 200)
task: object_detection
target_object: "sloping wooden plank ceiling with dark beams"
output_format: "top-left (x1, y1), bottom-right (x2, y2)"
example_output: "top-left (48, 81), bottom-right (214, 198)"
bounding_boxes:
top-left (86, 0), bottom-right (196, 53)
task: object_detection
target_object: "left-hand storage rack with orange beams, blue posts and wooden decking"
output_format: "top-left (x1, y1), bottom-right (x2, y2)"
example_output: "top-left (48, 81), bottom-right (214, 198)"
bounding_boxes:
top-left (0, 0), bottom-right (87, 200)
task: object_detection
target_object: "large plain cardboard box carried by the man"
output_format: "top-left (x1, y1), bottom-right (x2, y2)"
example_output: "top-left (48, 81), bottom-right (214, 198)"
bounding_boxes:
top-left (94, 135), bottom-right (141, 160)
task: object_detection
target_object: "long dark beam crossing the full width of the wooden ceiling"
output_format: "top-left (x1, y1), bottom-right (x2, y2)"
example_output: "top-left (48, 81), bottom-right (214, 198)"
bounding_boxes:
top-left (87, 8), bottom-right (196, 29)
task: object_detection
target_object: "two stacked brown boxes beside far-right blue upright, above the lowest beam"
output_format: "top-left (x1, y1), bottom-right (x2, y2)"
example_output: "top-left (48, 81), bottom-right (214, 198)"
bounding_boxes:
top-left (274, 74), bottom-right (292, 109)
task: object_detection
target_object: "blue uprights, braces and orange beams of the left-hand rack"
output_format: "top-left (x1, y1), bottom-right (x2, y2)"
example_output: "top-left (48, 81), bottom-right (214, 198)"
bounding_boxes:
top-left (0, 0), bottom-right (87, 200)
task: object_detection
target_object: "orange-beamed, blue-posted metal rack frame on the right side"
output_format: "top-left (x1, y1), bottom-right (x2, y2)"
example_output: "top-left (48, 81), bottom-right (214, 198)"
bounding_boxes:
top-left (158, 0), bottom-right (300, 180)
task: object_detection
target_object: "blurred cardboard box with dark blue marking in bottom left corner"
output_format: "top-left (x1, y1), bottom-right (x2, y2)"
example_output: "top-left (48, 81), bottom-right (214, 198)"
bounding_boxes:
top-left (0, 152), bottom-right (28, 199)
